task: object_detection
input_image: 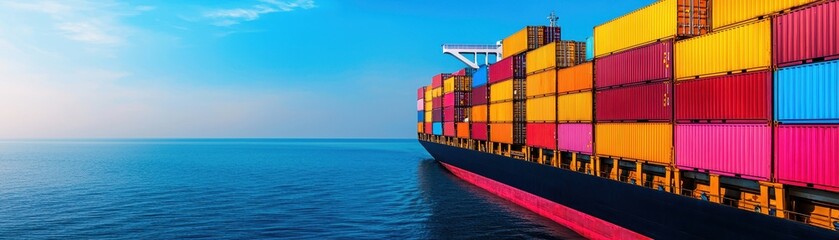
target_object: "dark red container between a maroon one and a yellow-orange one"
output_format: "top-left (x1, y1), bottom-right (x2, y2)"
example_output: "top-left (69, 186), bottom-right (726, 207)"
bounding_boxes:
top-left (592, 82), bottom-right (672, 122)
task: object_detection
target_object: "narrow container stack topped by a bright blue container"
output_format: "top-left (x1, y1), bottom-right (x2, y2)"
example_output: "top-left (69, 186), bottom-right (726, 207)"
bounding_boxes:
top-left (468, 65), bottom-right (489, 141)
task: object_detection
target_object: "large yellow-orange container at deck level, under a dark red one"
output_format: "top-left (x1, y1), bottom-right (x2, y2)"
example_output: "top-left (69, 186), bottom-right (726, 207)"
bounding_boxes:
top-left (594, 123), bottom-right (673, 164)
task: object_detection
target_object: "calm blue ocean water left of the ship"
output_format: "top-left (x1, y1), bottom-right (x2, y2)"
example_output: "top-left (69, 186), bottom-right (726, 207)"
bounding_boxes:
top-left (0, 139), bottom-right (582, 239)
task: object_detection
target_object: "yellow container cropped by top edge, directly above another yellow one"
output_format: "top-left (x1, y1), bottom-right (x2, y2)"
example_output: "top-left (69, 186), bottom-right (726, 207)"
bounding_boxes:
top-left (711, 0), bottom-right (817, 31)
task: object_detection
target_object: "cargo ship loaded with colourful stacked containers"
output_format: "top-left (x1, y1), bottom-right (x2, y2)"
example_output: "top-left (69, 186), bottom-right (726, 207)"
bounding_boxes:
top-left (417, 0), bottom-right (839, 239)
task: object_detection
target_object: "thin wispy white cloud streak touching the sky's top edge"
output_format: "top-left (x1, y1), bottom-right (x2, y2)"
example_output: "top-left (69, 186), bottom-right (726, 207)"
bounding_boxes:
top-left (204, 0), bottom-right (317, 27)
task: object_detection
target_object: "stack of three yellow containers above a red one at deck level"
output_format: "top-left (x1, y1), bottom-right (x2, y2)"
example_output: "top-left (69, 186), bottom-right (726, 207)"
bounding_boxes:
top-left (525, 41), bottom-right (585, 150)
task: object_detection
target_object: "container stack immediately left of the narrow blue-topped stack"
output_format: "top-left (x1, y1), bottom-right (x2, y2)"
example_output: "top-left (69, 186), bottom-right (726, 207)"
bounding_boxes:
top-left (443, 70), bottom-right (472, 138)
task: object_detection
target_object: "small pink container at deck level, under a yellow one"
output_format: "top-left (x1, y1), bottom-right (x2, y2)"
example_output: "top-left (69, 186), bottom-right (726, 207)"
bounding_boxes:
top-left (556, 123), bottom-right (594, 154)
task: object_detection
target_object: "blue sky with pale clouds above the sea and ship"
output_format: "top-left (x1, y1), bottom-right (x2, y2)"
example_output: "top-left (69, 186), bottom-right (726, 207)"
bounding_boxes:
top-left (0, 0), bottom-right (653, 138)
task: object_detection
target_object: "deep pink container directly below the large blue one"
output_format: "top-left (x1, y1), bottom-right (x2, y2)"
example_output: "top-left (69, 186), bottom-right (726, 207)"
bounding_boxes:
top-left (775, 125), bottom-right (839, 191)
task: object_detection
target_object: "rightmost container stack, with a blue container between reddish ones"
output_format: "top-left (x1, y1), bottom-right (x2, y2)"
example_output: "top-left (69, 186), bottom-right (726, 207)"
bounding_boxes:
top-left (772, 1), bottom-right (839, 191)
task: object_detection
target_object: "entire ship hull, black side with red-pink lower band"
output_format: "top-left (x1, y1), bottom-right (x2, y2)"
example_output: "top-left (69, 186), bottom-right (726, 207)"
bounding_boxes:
top-left (420, 140), bottom-right (839, 239)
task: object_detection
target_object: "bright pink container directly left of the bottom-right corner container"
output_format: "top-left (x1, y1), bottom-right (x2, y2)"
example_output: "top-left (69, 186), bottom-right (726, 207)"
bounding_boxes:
top-left (674, 123), bottom-right (772, 180)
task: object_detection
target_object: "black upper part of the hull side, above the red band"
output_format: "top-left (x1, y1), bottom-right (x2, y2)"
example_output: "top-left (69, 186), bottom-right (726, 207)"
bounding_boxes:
top-left (420, 141), bottom-right (839, 239)
